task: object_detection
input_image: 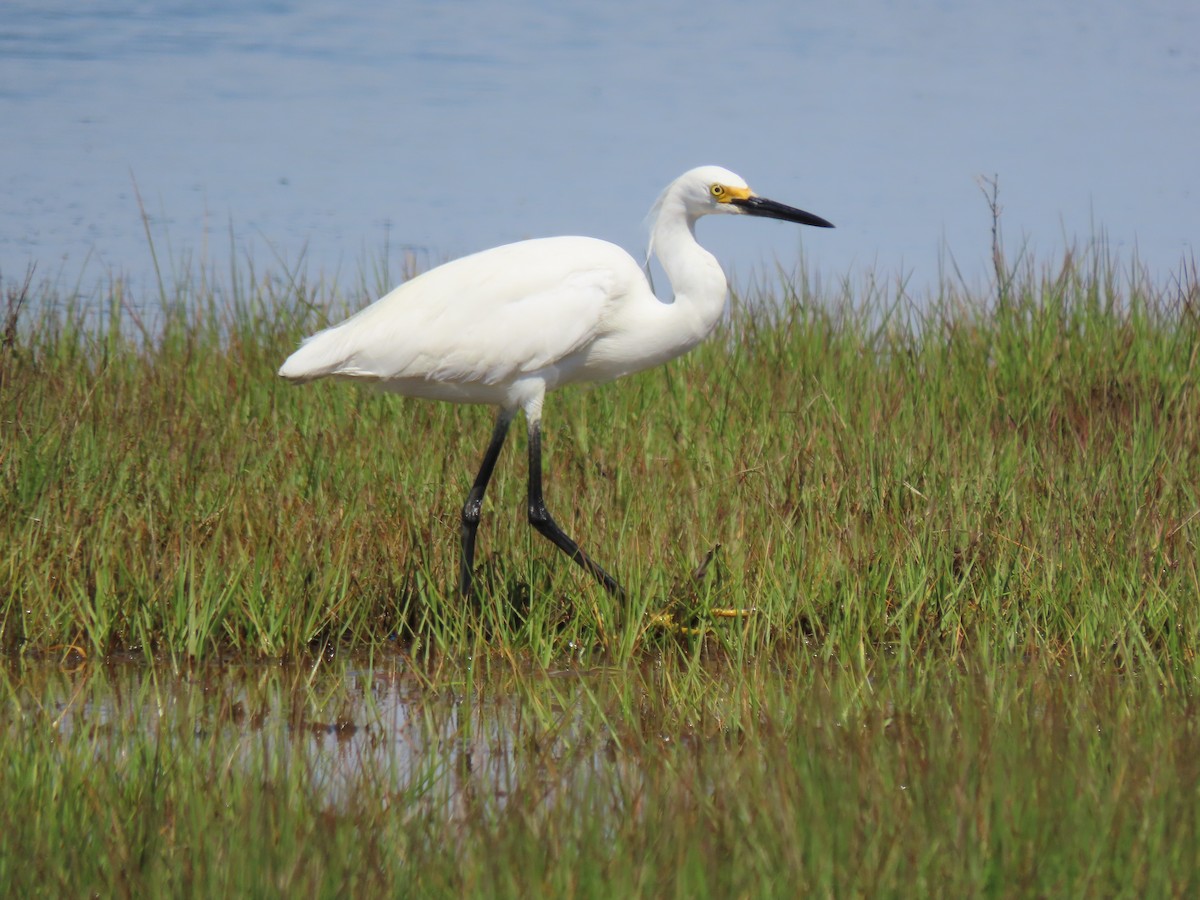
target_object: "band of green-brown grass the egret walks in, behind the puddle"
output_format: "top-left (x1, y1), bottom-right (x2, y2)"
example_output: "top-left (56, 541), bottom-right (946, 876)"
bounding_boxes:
top-left (7, 244), bottom-right (1200, 674)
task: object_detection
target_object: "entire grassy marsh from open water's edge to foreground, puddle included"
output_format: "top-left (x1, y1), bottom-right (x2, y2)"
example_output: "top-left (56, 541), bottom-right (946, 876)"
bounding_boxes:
top-left (0, 243), bottom-right (1200, 896)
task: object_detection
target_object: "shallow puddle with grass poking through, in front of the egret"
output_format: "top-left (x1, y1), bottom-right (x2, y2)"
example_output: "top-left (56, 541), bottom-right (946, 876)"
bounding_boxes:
top-left (18, 665), bottom-right (643, 816)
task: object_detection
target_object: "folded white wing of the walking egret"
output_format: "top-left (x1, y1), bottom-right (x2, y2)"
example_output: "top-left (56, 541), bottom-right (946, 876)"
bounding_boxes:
top-left (283, 238), bottom-right (641, 384)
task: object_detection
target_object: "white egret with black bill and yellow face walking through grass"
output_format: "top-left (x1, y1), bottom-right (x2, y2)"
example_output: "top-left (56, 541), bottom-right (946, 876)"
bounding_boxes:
top-left (280, 166), bottom-right (833, 596)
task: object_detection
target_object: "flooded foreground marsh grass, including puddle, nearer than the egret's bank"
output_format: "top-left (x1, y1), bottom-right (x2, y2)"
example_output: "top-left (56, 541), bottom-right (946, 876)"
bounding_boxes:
top-left (0, 654), bottom-right (1200, 898)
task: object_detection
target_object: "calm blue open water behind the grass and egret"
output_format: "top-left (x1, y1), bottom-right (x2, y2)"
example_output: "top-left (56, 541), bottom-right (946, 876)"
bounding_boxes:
top-left (0, 0), bottom-right (1200, 300)
